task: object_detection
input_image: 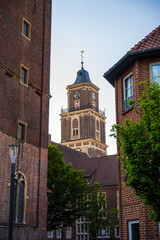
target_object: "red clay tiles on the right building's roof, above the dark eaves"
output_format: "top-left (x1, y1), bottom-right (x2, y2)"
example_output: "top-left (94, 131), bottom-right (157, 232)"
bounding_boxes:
top-left (129, 26), bottom-right (160, 52)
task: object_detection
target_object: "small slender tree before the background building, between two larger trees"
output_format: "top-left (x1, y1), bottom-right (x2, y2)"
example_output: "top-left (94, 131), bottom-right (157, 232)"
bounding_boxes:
top-left (85, 182), bottom-right (117, 240)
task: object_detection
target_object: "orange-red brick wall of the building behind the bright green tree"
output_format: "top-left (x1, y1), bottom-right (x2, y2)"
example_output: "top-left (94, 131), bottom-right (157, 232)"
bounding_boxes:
top-left (115, 58), bottom-right (160, 240)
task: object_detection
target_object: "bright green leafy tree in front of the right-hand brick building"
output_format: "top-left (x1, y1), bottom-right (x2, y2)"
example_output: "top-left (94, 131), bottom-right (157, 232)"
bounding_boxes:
top-left (111, 83), bottom-right (160, 221)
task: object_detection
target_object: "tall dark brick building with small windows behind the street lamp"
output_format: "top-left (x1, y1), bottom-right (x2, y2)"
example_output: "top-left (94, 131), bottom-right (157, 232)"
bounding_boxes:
top-left (0, 0), bottom-right (51, 240)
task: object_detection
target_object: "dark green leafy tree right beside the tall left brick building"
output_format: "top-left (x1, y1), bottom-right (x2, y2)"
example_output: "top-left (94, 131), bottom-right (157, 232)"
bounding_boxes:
top-left (48, 145), bottom-right (87, 230)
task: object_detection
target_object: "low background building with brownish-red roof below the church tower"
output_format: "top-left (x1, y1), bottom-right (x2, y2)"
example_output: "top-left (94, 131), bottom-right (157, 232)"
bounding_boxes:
top-left (48, 142), bottom-right (119, 240)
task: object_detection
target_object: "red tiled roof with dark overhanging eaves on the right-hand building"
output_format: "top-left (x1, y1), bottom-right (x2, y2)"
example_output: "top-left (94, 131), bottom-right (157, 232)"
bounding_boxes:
top-left (103, 26), bottom-right (160, 87)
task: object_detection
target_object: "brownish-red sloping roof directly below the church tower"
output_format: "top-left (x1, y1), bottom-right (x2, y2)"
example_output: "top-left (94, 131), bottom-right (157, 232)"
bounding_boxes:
top-left (52, 143), bottom-right (118, 186)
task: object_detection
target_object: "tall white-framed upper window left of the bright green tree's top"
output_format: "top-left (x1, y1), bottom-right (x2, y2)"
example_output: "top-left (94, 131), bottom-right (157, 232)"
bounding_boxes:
top-left (123, 74), bottom-right (133, 111)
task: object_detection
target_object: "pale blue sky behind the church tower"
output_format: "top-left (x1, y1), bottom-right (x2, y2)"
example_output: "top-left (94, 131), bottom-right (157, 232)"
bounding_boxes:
top-left (49, 0), bottom-right (160, 155)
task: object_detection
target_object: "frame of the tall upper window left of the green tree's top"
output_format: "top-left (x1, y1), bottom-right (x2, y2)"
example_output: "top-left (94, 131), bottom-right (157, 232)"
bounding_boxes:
top-left (123, 72), bottom-right (133, 112)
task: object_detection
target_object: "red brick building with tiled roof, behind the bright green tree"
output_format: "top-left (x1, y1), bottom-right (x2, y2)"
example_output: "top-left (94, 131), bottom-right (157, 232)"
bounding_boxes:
top-left (104, 26), bottom-right (160, 240)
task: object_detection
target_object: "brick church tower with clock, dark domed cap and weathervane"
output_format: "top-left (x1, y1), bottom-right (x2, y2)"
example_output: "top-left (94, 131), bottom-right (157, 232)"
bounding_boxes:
top-left (60, 52), bottom-right (108, 157)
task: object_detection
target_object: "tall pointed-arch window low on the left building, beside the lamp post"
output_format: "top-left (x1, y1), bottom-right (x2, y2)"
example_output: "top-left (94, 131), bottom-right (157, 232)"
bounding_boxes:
top-left (13, 172), bottom-right (26, 223)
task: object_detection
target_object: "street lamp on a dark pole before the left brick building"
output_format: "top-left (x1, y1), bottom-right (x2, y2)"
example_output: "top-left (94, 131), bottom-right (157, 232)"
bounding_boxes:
top-left (8, 145), bottom-right (18, 240)
